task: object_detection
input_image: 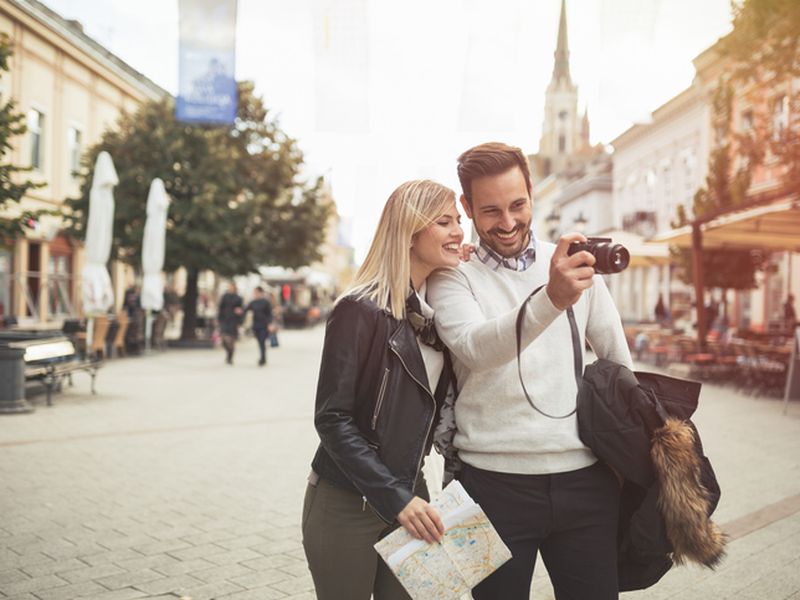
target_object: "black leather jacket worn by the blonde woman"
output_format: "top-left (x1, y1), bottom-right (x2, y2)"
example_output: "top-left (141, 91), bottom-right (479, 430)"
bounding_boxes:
top-left (312, 297), bottom-right (452, 523)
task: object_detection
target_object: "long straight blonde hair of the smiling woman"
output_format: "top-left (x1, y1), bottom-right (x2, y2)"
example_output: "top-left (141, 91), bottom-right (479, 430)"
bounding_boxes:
top-left (342, 179), bottom-right (456, 319)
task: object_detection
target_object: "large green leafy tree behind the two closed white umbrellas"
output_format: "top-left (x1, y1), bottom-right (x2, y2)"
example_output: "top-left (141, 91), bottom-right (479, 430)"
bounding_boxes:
top-left (68, 82), bottom-right (330, 339)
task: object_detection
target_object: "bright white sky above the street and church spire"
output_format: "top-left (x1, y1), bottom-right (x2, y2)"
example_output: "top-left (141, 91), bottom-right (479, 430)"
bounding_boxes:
top-left (44, 0), bottom-right (730, 258)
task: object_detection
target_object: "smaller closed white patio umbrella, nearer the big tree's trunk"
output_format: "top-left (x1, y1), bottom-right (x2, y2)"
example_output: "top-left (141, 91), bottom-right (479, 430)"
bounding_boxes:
top-left (141, 178), bottom-right (169, 348)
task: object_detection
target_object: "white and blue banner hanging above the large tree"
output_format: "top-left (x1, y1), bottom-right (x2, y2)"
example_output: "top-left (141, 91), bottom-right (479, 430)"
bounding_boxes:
top-left (175, 0), bottom-right (237, 124)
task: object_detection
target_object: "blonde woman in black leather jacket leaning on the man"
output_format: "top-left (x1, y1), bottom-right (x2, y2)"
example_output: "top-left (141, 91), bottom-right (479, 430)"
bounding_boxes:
top-left (302, 181), bottom-right (464, 600)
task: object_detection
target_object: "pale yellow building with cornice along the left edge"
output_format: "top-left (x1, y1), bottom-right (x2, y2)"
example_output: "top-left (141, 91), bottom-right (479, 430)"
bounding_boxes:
top-left (0, 0), bottom-right (167, 320)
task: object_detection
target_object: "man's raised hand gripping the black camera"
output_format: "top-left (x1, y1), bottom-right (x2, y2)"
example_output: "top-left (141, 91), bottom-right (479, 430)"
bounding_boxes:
top-left (546, 233), bottom-right (595, 310)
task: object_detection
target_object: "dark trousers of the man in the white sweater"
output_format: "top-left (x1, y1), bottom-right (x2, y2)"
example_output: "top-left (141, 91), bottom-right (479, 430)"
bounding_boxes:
top-left (459, 462), bottom-right (619, 600)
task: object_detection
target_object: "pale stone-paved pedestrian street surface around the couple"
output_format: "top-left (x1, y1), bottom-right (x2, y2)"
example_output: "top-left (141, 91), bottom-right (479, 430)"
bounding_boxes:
top-left (0, 327), bottom-right (800, 600)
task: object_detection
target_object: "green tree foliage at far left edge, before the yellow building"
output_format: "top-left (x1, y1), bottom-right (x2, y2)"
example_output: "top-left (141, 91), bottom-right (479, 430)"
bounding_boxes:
top-left (0, 34), bottom-right (43, 243)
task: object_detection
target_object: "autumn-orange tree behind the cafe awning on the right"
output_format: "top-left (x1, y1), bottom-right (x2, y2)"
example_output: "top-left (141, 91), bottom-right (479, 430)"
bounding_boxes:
top-left (671, 0), bottom-right (800, 330)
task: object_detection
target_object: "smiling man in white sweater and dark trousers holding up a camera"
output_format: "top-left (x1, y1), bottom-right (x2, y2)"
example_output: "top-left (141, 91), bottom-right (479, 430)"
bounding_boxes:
top-left (428, 143), bottom-right (632, 600)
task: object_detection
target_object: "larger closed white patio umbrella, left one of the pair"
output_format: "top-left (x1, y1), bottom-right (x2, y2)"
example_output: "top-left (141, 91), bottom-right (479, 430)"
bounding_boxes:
top-left (81, 152), bottom-right (119, 314)
